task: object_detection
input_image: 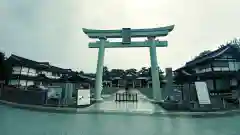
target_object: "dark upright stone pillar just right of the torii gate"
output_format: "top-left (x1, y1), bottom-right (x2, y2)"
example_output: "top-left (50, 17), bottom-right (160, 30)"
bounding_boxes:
top-left (163, 68), bottom-right (174, 99)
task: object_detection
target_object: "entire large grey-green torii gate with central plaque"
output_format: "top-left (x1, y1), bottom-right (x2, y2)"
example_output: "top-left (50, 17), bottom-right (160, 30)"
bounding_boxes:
top-left (83, 25), bottom-right (174, 102)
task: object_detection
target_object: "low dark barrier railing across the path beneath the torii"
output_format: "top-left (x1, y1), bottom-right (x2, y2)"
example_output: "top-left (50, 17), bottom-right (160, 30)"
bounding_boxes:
top-left (115, 92), bottom-right (138, 102)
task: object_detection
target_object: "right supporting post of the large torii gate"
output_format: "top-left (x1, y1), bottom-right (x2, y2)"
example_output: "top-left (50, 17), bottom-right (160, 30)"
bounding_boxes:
top-left (148, 37), bottom-right (162, 102)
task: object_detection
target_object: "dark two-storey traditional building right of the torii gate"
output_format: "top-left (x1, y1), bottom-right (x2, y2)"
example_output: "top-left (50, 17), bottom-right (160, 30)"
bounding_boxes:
top-left (174, 45), bottom-right (240, 109)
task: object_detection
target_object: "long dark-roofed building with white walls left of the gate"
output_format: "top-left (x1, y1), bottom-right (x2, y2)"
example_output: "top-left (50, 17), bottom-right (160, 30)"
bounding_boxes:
top-left (7, 55), bottom-right (93, 86)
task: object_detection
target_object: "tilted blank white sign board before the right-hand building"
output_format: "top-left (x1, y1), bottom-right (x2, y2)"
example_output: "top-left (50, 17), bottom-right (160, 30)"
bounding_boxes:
top-left (195, 82), bottom-right (211, 104)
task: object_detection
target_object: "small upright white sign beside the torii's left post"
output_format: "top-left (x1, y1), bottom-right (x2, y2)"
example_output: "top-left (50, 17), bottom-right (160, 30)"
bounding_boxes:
top-left (77, 89), bottom-right (90, 105)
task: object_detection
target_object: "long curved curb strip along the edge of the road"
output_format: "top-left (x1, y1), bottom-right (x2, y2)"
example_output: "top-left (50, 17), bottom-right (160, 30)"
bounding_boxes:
top-left (0, 100), bottom-right (240, 118)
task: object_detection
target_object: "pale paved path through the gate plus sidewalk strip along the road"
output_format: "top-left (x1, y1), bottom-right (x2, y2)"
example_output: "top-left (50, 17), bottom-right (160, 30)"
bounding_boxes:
top-left (0, 89), bottom-right (240, 117)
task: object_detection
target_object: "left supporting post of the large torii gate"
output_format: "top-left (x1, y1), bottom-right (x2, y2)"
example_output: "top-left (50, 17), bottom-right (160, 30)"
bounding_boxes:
top-left (95, 38), bottom-right (106, 101)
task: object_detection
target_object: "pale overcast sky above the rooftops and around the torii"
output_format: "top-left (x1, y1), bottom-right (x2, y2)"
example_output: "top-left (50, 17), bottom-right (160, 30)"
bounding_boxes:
top-left (0, 0), bottom-right (240, 72)
